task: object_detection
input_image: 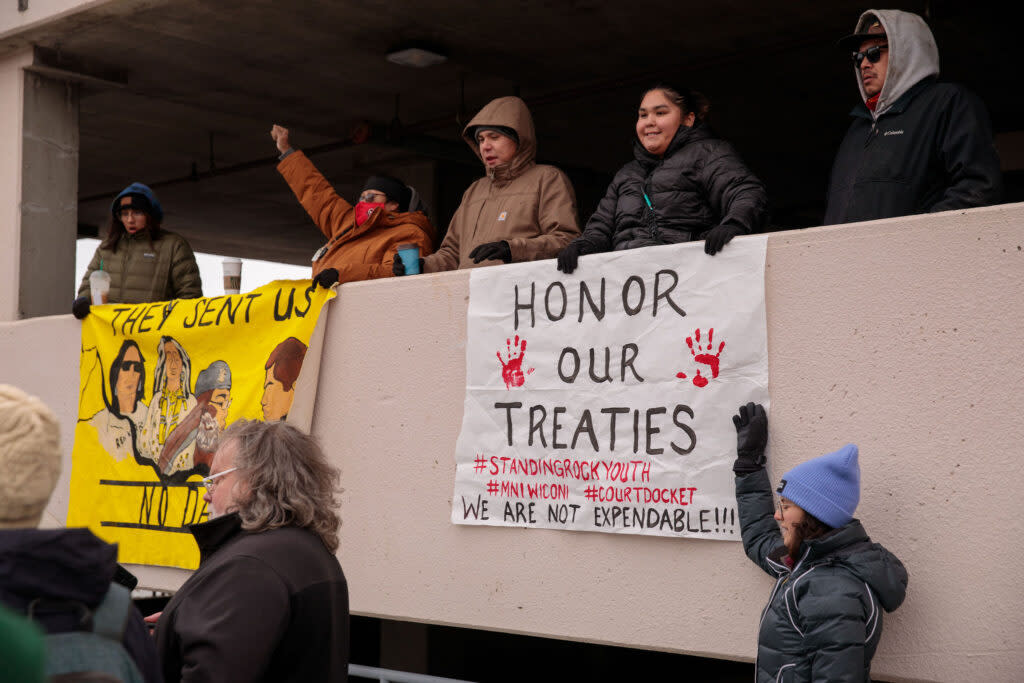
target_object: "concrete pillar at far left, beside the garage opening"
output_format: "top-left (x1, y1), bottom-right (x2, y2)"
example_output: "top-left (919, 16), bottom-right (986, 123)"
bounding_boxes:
top-left (0, 51), bottom-right (79, 321)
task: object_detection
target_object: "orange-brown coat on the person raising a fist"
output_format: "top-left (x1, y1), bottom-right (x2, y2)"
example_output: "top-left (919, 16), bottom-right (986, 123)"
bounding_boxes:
top-left (278, 152), bottom-right (436, 283)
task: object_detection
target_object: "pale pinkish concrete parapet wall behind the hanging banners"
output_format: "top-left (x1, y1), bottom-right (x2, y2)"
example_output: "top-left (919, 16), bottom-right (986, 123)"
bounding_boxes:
top-left (0, 205), bottom-right (1024, 681)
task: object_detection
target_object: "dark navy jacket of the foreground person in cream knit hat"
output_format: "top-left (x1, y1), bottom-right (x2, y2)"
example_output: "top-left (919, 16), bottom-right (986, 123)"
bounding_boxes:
top-left (0, 528), bottom-right (161, 683)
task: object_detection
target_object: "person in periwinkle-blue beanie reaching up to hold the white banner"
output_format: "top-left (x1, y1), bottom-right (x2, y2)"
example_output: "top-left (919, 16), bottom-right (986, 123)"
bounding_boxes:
top-left (732, 403), bottom-right (907, 683)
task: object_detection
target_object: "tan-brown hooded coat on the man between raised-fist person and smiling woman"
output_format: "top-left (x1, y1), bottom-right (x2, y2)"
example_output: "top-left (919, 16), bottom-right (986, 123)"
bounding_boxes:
top-left (423, 97), bottom-right (580, 272)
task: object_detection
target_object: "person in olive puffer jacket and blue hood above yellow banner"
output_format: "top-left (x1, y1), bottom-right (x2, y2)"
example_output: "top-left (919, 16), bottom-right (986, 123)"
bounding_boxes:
top-left (72, 182), bottom-right (203, 319)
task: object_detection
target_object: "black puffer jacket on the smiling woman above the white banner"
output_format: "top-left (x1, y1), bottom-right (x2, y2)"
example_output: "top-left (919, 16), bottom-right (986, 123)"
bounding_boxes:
top-left (575, 124), bottom-right (768, 254)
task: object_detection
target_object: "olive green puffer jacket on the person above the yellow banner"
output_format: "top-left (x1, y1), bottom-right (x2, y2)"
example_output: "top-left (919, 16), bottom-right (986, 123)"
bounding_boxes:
top-left (78, 230), bottom-right (203, 303)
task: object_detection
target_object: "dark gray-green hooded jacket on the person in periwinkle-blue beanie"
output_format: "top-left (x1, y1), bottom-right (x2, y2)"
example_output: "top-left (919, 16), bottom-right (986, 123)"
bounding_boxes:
top-left (736, 470), bottom-right (907, 683)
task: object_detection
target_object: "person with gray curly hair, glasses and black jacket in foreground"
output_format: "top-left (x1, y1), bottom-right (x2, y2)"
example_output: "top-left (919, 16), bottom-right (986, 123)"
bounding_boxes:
top-left (151, 420), bottom-right (348, 682)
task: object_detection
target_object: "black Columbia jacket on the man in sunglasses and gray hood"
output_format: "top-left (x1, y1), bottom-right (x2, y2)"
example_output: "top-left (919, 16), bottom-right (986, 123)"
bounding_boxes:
top-left (824, 78), bottom-right (1002, 225)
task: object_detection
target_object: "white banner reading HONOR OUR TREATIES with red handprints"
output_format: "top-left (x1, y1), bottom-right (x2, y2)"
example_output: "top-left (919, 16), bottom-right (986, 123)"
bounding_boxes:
top-left (452, 236), bottom-right (768, 541)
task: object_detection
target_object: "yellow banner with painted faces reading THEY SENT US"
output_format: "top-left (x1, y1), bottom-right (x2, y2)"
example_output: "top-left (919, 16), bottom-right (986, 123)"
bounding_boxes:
top-left (68, 281), bottom-right (334, 569)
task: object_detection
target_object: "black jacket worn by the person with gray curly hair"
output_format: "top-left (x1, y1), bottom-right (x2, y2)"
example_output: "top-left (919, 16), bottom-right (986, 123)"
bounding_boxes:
top-left (157, 514), bottom-right (348, 683)
